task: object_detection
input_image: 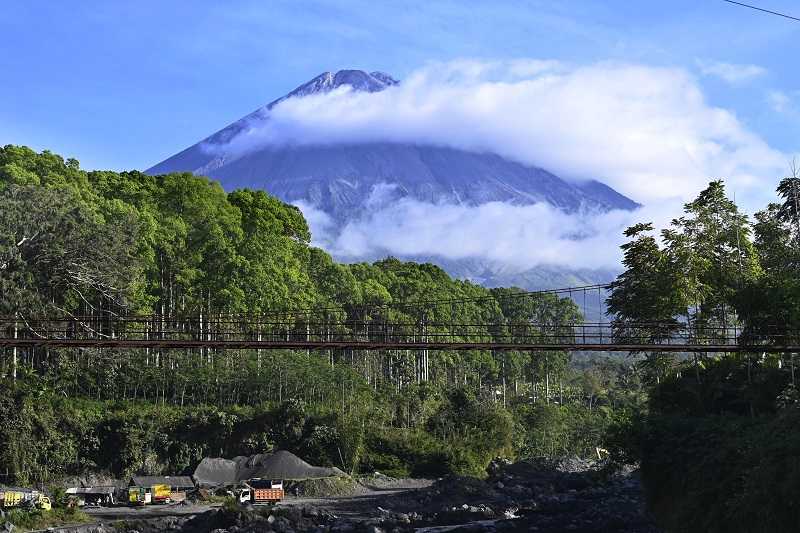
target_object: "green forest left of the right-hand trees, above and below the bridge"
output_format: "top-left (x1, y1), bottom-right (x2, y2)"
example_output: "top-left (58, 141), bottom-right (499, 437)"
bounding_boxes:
top-left (0, 146), bottom-right (641, 483)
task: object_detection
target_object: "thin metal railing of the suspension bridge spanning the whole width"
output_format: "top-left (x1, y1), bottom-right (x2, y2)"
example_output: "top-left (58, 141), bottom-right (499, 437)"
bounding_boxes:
top-left (0, 315), bottom-right (800, 351)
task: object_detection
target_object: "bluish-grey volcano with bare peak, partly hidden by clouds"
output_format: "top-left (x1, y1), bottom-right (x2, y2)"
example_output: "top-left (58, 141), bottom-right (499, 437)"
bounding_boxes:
top-left (147, 70), bottom-right (638, 285)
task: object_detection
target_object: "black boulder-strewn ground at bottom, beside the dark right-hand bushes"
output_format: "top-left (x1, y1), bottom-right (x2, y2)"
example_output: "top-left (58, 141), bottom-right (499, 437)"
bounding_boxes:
top-left (387, 459), bottom-right (658, 533)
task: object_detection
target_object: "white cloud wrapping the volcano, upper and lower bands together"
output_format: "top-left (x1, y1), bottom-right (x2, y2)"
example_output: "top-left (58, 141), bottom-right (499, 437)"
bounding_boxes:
top-left (206, 60), bottom-right (789, 270)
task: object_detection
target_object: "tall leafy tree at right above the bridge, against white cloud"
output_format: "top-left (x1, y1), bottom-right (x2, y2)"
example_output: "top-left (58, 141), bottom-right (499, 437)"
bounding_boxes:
top-left (607, 181), bottom-right (761, 381)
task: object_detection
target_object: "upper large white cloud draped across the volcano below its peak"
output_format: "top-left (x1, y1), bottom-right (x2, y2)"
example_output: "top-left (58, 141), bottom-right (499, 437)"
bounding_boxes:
top-left (212, 61), bottom-right (787, 210)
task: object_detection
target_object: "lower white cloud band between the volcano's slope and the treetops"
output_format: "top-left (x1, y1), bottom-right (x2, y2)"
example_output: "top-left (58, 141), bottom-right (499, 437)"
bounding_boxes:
top-left (297, 187), bottom-right (680, 273)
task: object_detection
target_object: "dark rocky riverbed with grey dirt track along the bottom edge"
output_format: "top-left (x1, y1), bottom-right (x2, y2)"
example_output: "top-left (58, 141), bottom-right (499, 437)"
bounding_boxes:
top-left (36, 459), bottom-right (658, 533)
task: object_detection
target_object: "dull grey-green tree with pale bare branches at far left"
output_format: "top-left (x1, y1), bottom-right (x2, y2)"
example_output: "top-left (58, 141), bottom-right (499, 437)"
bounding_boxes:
top-left (0, 185), bottom-right (139, 319)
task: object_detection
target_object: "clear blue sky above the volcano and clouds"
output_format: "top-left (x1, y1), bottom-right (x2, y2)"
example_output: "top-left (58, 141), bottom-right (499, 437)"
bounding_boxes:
top-left (0, 0), bottom-right (800, 169)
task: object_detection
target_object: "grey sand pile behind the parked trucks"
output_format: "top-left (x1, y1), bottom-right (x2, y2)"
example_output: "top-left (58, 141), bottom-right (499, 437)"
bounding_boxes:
top-left (194, 450), bottom-right (344, 486)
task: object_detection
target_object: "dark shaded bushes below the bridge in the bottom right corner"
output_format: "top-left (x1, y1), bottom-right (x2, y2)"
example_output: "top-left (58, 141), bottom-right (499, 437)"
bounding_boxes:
top-left (632, 357), bottom-right (800, 533)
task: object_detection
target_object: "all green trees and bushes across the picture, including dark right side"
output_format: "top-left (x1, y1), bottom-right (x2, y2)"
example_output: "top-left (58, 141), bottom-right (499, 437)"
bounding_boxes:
top-left (0, 145), bottom-right (800, 531)
